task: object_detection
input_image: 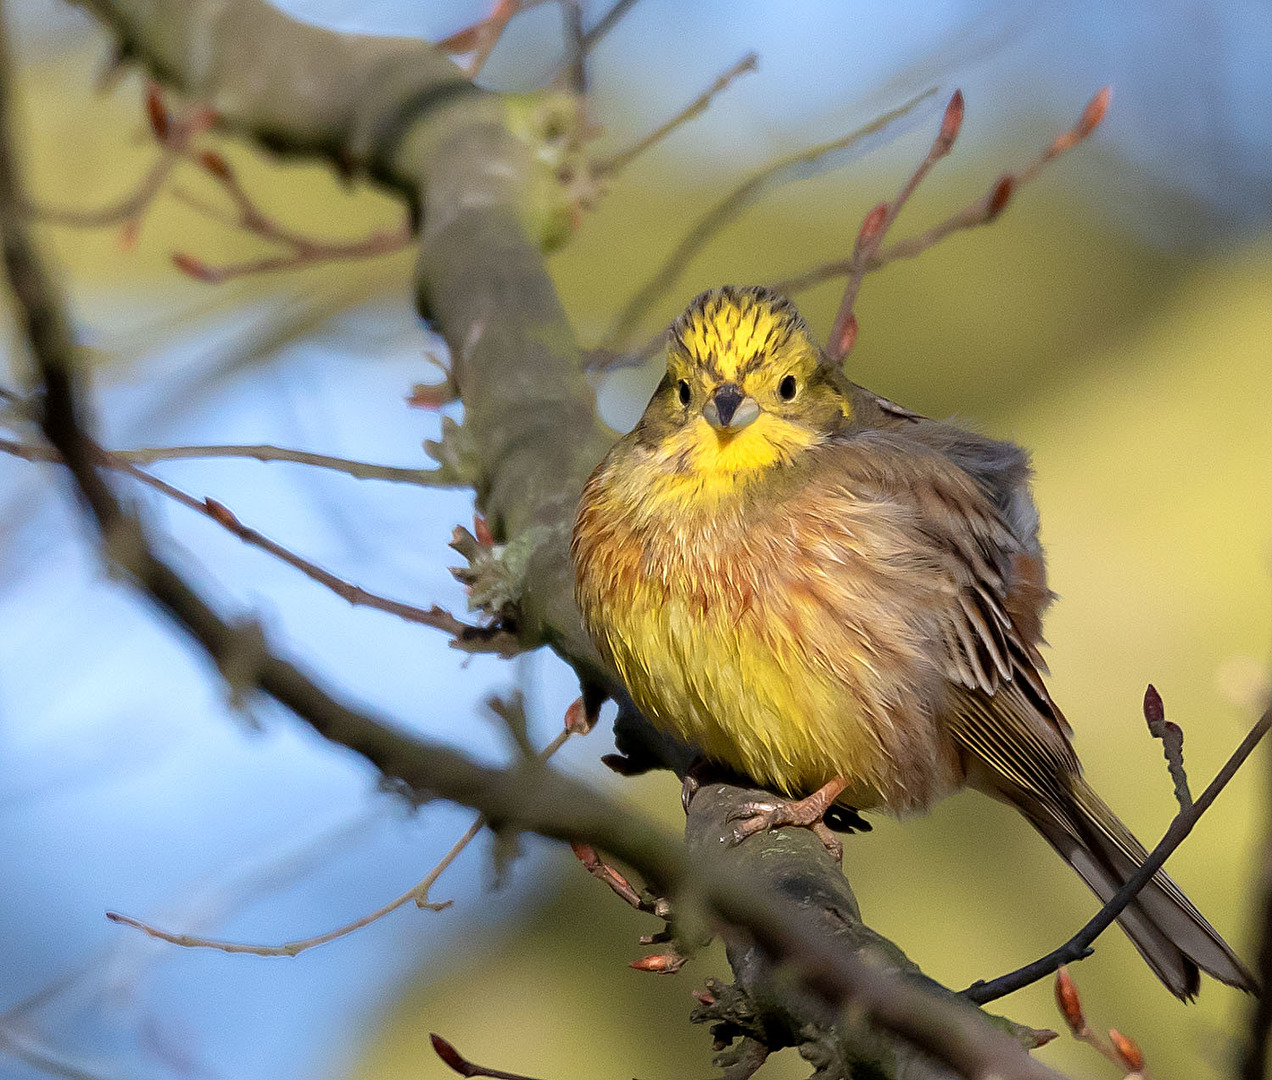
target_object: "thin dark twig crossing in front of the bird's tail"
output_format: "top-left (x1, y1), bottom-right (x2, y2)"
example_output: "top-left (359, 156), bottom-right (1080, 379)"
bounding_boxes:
top-left (963, 706), bottom-right (1272, 1005)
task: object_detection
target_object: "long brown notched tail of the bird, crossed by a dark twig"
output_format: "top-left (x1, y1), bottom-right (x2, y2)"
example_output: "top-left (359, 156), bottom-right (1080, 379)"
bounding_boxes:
top-left (1011, 775), bottom-right (1259, 1001)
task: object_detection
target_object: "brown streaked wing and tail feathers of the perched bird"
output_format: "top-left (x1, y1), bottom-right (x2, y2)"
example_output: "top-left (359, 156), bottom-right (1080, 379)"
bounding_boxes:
top-left (844, 429), bottom-right (1257, 999)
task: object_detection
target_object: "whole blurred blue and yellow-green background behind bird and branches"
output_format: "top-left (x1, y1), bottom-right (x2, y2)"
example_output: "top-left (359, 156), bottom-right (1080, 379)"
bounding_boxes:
top-left (0, 0), bottom-right (1272, 1080)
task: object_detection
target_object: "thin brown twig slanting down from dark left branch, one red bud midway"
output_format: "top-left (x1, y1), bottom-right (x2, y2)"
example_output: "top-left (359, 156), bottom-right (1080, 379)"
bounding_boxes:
top-left (0, 439), bottom-right (520, 656)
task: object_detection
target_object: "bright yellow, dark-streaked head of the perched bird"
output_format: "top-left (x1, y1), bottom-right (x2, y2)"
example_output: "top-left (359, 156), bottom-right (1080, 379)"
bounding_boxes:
top-left (637, 286), bottom-right (851, 488)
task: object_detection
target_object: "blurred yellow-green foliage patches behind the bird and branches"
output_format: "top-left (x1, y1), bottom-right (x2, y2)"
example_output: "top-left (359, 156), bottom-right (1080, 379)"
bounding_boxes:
top-left (14, 37), bottom-right (1272, 1080)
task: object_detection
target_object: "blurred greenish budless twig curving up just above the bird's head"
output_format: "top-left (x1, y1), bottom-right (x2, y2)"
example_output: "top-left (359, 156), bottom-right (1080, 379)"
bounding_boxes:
top-left (602, 90), bottom-right (935, 352)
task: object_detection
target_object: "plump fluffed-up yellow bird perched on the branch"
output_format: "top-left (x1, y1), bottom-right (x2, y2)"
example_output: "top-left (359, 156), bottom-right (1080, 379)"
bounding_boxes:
top-left (572, 287), bottom-right (1257, 1000)
